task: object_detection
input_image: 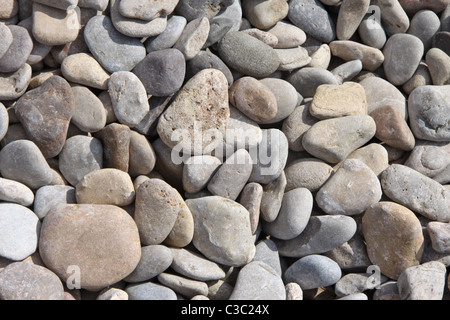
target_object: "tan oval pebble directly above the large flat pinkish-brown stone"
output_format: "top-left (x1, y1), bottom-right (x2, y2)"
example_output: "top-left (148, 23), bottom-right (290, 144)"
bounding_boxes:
top-left (75, 168), bottom-right (136, 206)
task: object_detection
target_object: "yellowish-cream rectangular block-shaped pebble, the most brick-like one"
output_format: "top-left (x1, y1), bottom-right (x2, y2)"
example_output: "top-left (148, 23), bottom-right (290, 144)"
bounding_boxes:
top-left (309, 81), bottom-right (367, 119)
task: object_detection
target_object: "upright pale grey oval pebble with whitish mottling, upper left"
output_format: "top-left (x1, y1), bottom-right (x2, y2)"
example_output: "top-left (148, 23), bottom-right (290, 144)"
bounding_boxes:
top-left (108, 71), bottom-right (150, 127)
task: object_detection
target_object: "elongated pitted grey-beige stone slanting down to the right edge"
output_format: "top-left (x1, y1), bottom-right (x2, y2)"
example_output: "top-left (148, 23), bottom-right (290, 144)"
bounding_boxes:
top-left (381, 164), bottom-right (450, 222)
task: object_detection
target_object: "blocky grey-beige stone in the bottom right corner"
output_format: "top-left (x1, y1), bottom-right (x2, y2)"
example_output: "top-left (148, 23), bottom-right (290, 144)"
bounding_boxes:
top-left (397, 261), bottom-right (447, 300)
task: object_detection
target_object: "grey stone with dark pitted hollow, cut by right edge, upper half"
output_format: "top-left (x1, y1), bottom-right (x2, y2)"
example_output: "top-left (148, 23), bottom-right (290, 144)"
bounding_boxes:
top-left (408, 85), bottom-right (450, 141)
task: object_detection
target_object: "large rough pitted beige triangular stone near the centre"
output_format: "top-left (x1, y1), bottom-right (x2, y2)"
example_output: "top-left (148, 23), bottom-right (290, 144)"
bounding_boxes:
top-left (157, 69), bottom-right (230, 154)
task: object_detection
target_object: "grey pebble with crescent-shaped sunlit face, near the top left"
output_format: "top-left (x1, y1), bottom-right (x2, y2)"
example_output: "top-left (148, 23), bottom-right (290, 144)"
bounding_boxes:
top-left (84, 16), bottom-right (146, 73)
